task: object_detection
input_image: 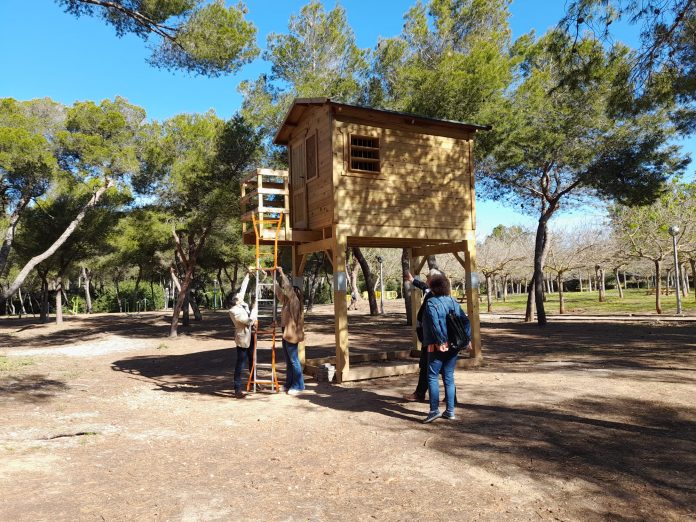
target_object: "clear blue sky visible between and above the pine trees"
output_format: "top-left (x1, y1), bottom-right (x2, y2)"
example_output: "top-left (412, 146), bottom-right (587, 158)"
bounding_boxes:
top-left (0, 0), bottom-right (696, 235)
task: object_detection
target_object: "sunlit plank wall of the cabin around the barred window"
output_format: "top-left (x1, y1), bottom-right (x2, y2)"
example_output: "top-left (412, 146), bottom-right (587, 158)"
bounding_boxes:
top-left (333, 115), bottom-right (474, 238)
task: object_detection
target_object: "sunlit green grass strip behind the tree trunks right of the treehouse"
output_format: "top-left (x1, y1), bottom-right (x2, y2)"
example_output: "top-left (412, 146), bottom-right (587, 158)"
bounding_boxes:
top-left (481, 288), bottom-right (696, 315)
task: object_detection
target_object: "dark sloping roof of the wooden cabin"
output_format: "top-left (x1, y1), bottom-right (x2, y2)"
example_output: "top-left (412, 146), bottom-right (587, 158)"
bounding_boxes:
top-left (273, 98), bottom-right (492, 145)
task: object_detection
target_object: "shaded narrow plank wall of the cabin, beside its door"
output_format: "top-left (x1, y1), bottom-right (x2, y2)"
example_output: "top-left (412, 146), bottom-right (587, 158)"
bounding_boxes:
top-left (289, 106), bottom-right (333, 230)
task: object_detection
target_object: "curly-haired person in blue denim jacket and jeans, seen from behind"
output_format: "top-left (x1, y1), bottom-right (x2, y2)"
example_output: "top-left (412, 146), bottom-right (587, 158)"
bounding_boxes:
top-left (423, 275), bottom-right (471, 423)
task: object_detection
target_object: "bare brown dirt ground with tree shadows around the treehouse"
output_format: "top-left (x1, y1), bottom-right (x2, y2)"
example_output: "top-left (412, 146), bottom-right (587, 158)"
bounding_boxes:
top-left (0, 300), bottom-right (696, 521)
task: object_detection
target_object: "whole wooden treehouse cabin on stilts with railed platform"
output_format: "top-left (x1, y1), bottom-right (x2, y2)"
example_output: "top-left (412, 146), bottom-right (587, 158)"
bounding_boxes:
top-left (242, 98), bottom-right (490, 382)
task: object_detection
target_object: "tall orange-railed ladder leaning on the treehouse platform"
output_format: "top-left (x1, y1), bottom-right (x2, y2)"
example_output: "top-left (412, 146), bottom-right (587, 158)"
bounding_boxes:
top-left (247, 214), bottom-right (283, 392)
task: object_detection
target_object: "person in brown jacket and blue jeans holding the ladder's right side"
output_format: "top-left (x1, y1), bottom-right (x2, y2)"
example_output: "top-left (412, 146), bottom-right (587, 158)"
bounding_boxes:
top-left (274, 267), bottom-right (304, 395)
